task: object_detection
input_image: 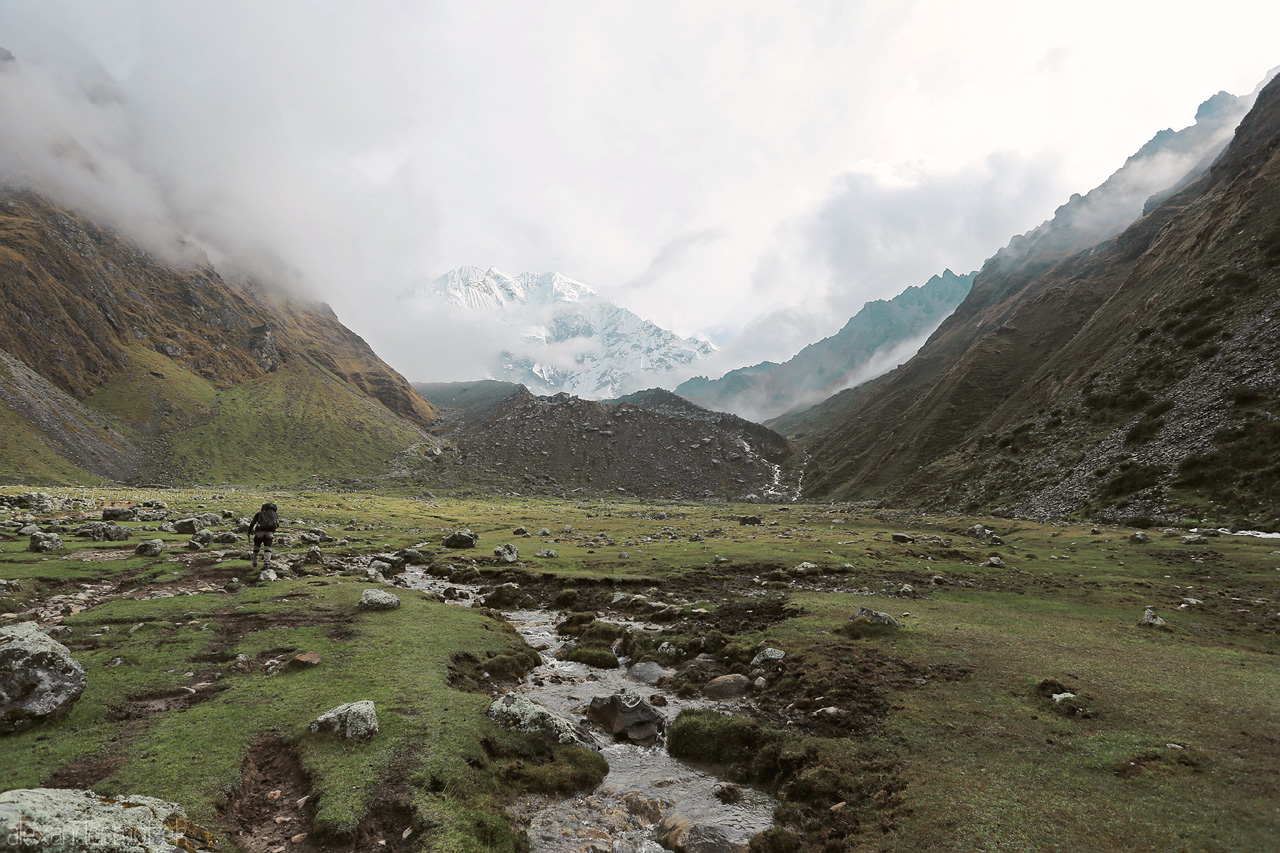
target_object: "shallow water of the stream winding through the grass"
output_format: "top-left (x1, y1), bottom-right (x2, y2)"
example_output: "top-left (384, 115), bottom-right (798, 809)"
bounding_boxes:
top-left (403, 573), bottom-right (777, 853)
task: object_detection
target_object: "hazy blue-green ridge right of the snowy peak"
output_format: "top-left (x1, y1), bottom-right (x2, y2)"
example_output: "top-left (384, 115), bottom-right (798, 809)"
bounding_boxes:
top-left (676, 270), bottom-right (974, 420)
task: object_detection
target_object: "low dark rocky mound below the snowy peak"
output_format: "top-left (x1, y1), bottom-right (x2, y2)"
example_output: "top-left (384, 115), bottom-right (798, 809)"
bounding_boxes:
top-left (415, 382), bottom-right (803, 498)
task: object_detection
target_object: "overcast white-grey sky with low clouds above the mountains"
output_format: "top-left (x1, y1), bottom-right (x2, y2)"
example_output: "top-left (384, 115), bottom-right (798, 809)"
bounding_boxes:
top-left (0, 0), bottom-right (1280, 380)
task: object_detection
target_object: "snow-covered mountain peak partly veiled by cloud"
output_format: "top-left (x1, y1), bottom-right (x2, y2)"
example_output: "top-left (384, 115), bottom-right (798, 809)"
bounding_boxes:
top-left (407, 266), bottom-right (714, 398)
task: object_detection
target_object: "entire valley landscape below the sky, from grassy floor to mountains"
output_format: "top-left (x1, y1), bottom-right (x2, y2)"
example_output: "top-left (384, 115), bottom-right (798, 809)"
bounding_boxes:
top-left (0, 54), bottom-right (1280, 853)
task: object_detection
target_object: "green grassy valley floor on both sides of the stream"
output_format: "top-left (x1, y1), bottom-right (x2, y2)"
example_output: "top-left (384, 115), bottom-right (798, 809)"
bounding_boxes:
top-left (0, 488), bottom-right (1280, 850)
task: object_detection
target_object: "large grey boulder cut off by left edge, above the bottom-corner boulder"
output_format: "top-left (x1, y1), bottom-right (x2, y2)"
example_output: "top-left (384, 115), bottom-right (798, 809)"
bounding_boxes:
top-left (0, 622), bottom-right (86, 734)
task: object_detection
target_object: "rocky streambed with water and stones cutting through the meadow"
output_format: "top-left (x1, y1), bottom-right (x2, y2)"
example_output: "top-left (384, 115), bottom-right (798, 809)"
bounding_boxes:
top-left (401, 570), bottom-right (777, 853)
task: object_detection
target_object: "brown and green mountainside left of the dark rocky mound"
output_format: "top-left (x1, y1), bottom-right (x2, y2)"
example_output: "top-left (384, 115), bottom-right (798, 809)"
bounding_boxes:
top-left (0, 192), bottom-right (436, 482)
